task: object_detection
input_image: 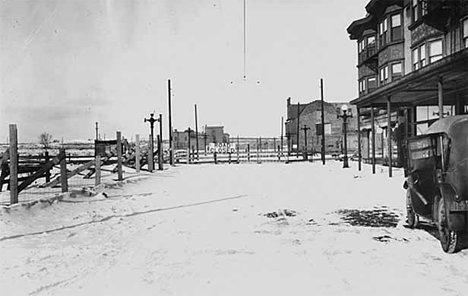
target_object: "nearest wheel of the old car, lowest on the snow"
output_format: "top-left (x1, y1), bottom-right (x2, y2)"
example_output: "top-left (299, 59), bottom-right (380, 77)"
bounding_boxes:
top-left (435, 196), bottom-right (464, 254)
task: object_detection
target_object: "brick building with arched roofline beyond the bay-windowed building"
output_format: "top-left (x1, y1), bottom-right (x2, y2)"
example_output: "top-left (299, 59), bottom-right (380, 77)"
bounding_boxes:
top-left (285, 98), bottom-right (358, 154)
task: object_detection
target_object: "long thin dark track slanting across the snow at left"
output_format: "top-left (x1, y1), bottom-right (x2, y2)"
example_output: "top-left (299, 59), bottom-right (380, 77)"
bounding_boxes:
top-left (0, 194), bottom-right (248, 242)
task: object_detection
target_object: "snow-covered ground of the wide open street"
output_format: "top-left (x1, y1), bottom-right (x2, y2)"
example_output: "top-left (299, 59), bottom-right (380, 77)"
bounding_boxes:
top-left (0, 161), bottom-right (468, 295)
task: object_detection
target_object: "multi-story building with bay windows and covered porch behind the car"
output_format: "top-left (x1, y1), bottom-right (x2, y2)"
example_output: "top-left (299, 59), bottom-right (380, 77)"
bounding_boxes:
top-left (347, 0), bottom-right (468, 170)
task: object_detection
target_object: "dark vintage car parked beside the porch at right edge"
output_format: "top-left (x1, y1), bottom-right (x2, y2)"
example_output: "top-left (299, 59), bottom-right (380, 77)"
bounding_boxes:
top-left (403, 115), bottom-right (468, 253)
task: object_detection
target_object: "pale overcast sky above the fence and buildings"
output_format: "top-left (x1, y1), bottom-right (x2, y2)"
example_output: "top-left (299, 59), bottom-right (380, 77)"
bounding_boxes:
top-left (0, 0), bottom-right (368, 142)
